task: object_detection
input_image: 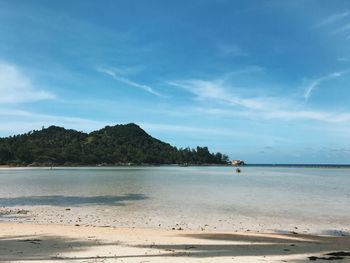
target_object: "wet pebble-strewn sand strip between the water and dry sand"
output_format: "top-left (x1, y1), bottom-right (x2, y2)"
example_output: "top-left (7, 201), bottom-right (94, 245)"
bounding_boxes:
top-left (0, 204), bottom-right (350, 235)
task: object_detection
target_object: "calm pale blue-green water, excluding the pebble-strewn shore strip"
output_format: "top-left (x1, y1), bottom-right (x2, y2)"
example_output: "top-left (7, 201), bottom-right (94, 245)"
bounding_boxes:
top-left (0, 166), bottom-right (350, 233)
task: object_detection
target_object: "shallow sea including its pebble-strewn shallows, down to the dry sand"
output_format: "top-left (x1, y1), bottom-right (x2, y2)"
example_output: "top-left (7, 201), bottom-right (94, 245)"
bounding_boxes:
top-left (0, 166), bottom-right (350, 235)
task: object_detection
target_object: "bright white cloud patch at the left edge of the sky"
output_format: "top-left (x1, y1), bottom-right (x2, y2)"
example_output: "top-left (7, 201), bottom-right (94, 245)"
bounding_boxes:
top-left (0, 62), bottom-right (55, 104)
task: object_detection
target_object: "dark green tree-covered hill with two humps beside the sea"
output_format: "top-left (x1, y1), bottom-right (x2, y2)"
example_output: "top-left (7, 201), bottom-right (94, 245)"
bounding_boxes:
top-left (0, 123), bottom-right (228, 166)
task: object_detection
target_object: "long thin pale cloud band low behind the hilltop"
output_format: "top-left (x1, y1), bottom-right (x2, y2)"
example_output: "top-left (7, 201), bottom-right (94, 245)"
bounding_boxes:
top-left (0, 108), bottom-right (286, 141)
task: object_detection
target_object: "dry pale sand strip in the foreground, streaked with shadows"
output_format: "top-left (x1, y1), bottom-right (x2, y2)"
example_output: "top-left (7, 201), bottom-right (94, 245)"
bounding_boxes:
top-left (0, 222), bottom-right (350, 262)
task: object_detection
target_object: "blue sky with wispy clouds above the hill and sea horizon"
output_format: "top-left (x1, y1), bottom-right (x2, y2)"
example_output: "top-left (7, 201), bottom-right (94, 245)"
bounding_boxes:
top-left (0, 0), bottom-right (350, 164)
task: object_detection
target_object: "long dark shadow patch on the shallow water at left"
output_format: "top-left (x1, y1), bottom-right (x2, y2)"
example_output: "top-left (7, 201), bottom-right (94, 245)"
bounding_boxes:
top-left (0, 194), bottom-right (147, 207)
